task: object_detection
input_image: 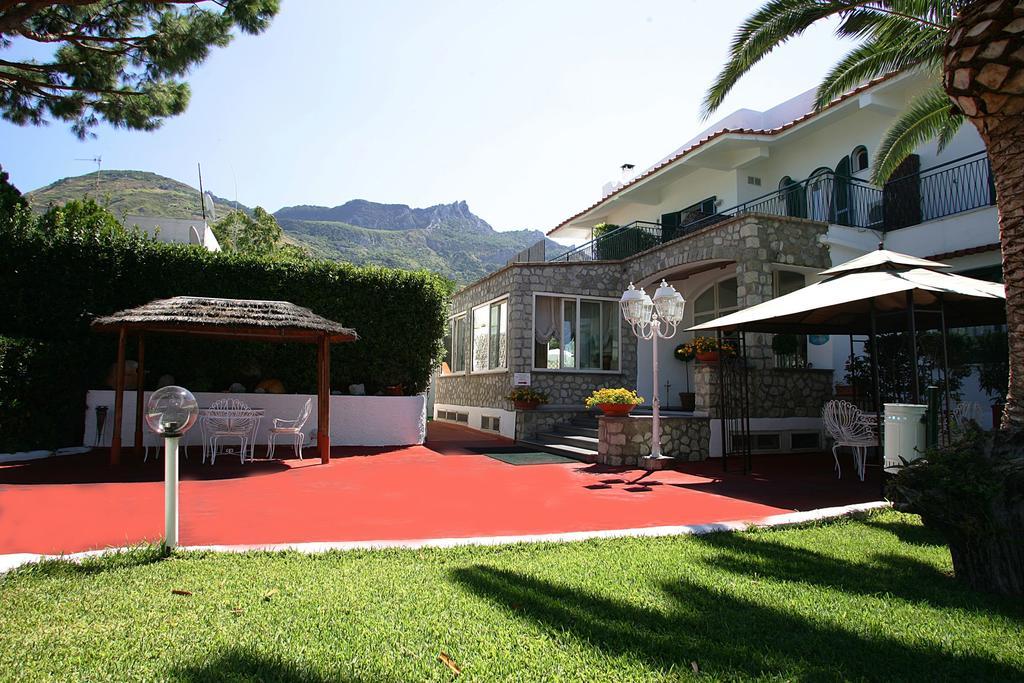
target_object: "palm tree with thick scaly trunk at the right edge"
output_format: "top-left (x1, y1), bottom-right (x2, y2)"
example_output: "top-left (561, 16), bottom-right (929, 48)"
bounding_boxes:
top-left (703, 0), bottom-right (1024, 431)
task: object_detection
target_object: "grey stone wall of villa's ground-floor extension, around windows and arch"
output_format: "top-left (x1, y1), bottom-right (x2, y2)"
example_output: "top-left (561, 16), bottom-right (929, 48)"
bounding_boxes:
top-left (436, 214), bottom-right (830, 432)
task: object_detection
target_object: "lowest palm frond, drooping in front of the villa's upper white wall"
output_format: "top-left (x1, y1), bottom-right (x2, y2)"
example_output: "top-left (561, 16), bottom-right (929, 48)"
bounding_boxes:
top-left (871, 85), bottom-right (964, 185)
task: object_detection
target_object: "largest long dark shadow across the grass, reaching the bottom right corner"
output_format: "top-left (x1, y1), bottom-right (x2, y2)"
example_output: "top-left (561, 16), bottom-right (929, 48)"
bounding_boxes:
top-left (453, 565), bottom-right (1024, 681)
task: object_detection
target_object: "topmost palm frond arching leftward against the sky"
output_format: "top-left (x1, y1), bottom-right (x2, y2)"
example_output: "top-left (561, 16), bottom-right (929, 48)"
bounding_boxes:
top-left (701, 0), bottom-right (956, 119)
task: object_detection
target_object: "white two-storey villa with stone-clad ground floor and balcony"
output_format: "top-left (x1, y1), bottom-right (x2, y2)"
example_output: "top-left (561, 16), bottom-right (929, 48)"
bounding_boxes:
top-left (436, 73), bottom-right (1001, 457)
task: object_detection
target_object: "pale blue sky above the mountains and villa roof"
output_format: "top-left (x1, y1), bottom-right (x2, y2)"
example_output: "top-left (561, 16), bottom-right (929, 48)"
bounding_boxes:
top-left (0, 0), bottom-right (850, 230)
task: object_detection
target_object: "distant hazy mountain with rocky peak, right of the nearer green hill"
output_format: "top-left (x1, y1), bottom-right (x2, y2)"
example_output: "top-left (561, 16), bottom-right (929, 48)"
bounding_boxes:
top-left (273, 200), bottom-right (544, 284)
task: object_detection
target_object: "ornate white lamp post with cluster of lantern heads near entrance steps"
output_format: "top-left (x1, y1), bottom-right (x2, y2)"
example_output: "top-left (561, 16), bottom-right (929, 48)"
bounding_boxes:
top-left (618, 280), bottom-right (686, 460)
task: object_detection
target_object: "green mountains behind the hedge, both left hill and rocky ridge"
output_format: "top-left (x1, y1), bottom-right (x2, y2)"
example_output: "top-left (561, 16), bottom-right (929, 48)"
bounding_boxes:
top-left (26, 171), bottom-right (558, 284)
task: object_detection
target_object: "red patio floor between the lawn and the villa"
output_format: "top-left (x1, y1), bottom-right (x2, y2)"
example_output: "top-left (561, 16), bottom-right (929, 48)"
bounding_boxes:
top-left (0, 423), bottom-right (879, 554)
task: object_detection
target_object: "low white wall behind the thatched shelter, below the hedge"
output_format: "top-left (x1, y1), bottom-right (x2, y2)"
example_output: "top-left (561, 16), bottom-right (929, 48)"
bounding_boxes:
top-left (85, 390), bottom-right (427, 446)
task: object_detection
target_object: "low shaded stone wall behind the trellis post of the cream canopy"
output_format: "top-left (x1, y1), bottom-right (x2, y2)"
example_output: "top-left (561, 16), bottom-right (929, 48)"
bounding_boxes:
top-left (693, 364), bottom-right (833, 418)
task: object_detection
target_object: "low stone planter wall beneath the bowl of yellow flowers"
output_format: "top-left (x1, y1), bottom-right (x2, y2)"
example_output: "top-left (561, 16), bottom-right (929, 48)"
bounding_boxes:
top-left (597, 415), bottom-right (711, 467)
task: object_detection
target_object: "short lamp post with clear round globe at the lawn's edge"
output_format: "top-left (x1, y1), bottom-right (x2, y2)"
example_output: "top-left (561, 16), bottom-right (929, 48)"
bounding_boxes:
top-left (145, 386), bottom-right (199, 550)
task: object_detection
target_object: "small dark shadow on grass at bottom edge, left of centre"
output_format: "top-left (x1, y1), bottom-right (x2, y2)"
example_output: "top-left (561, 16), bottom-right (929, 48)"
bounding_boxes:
top-left (168, 649), bottom-right (381, 683)
